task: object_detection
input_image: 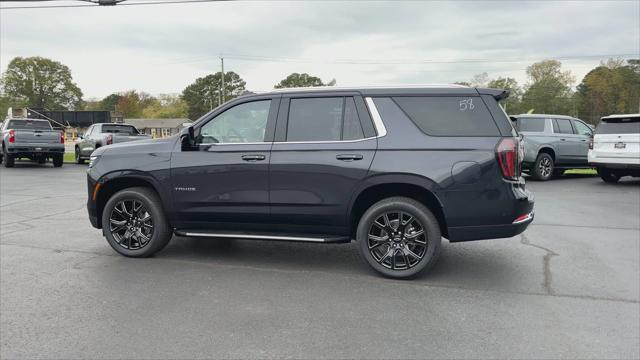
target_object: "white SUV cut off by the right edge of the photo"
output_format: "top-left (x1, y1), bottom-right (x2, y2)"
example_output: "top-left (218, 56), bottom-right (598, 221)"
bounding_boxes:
top-left (589, 114), bottom-right (640, 182)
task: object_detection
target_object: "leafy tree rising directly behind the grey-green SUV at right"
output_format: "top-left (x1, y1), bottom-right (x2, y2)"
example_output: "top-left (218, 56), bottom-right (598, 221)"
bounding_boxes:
top-left (522, 60), bottom-right (576, 115)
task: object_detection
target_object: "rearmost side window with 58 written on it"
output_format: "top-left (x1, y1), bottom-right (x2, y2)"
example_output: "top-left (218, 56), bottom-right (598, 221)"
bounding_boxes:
top-left (393, 96), bottom-right (500, 136)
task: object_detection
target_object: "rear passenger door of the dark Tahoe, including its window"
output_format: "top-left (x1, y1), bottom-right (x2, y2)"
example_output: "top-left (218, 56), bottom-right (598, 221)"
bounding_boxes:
top-left (269, 93), bottom-right (377, 235)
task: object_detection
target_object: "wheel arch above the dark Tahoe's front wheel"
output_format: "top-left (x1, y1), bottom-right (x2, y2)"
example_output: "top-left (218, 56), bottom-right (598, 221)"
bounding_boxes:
top-left (95, 172), bottom-right (168, 227)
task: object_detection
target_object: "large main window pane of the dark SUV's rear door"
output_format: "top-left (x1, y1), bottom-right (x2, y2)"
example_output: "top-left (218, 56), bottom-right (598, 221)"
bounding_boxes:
top-left (287, 97), bottom-right (344, 141)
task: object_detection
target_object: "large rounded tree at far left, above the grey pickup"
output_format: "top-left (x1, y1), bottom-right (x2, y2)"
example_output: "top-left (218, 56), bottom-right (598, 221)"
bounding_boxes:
top-left (0, 56), bottom-right (82, 110)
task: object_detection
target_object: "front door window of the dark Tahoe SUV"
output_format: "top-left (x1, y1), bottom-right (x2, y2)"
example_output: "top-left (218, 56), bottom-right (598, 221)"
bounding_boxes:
top-left (196, 100), bottom-right (271, 144)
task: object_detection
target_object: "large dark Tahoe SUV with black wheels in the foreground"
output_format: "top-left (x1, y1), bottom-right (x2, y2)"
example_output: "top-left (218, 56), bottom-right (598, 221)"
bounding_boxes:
top-left (87, 86), bottom-right (533, 278)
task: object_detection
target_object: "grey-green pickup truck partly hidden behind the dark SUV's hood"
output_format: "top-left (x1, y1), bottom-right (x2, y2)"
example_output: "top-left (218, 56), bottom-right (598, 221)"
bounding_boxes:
top-left (75, 123), bottom-right (151, 164)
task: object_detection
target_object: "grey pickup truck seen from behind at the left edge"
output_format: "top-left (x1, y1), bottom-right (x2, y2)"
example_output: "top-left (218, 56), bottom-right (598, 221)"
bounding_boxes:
top-left (0, 118), bottom-right (64, 168)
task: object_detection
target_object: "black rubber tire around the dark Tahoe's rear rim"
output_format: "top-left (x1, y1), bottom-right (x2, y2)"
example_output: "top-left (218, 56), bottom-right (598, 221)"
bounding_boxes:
top-left (356, 198), bottom-right (442, 279)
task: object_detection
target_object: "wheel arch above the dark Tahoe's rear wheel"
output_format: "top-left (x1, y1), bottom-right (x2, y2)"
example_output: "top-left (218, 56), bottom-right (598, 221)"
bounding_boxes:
top-left (348, 174), bottom-right (448, 238)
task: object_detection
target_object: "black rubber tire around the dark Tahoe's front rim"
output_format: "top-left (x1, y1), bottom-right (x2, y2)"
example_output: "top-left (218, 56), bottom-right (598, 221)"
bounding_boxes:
top-left (102, 189), bottom-right (170, 257)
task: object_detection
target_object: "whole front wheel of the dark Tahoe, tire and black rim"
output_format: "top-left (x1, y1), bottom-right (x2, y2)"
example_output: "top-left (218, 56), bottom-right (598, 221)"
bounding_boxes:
top-left (102, 187), bottom-right (172, 258)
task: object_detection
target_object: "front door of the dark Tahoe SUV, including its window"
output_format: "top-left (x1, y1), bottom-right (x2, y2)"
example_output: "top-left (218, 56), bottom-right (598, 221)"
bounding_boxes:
top-left (171, 98), bottom-right (279, 229)
